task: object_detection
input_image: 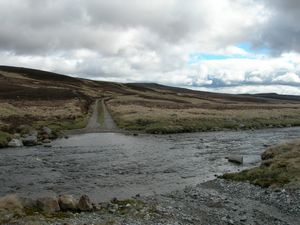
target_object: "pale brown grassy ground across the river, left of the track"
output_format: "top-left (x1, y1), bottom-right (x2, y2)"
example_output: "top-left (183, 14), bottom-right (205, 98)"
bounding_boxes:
top-left (0, 99), bottom-right (91, 147)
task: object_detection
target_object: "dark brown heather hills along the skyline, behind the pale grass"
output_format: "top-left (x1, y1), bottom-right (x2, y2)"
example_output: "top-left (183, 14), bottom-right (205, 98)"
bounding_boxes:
top-left (0, 66), bottom-right (300, 102)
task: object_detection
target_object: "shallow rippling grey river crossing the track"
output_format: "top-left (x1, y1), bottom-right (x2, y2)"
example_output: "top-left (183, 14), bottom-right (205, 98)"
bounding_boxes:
top-left (0, 127), bottom-right (300, 201)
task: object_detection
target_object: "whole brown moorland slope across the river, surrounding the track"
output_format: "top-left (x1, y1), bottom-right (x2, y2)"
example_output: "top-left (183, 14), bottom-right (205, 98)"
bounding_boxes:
top-left (0, 66), bottom-right (300, 145)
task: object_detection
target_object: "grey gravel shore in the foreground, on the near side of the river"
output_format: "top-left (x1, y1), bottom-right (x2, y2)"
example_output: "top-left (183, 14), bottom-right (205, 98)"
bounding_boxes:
top-left (0, 179), bottom-right (300, 225)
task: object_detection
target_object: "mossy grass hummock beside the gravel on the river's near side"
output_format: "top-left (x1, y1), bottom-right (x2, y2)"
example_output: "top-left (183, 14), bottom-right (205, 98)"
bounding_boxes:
top-left (223, 140), bottom-right (300, 189)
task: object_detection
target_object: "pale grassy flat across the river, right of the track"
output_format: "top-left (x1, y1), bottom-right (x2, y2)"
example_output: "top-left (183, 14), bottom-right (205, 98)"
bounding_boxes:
top-left (108, 96), bottom-right (300, 133)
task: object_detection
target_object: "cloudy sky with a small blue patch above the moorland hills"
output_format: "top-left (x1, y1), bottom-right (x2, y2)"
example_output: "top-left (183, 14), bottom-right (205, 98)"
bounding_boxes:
top-left (0, 0), bottom-right (300, 95)
